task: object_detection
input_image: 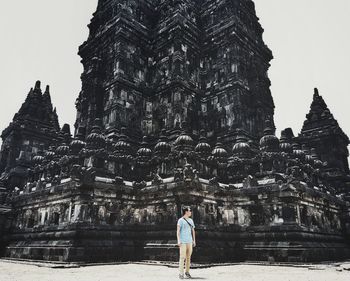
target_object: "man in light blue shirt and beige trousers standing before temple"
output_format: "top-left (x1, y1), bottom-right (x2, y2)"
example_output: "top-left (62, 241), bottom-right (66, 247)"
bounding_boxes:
top-left (177, 207), bottom-right (196, 279)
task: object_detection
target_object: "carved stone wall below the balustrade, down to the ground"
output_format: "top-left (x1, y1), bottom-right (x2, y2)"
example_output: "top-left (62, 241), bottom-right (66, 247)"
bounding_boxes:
top-left (7, 178), bottom-right (349, 262)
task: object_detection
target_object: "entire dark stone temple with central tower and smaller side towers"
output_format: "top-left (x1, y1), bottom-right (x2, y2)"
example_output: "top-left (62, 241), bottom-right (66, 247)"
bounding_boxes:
top-left (0, 0), bottom-right (350, 262)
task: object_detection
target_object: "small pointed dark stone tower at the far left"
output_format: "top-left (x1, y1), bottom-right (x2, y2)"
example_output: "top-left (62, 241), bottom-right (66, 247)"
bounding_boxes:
top-left (0, 81), bottom-right (60, 189)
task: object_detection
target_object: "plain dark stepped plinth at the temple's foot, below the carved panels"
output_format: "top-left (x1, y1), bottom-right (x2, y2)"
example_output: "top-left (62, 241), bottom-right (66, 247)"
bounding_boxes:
top-left (6, 226), bottom-right (350, 263)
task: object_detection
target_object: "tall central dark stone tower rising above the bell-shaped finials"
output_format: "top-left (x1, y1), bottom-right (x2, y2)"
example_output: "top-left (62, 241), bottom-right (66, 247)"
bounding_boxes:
top-left (75, 0), bottom-right (274, 142)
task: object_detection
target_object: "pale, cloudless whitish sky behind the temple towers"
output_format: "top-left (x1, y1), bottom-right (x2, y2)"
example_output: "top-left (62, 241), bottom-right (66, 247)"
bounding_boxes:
top-left (0, 0), bottom-right (350, 145)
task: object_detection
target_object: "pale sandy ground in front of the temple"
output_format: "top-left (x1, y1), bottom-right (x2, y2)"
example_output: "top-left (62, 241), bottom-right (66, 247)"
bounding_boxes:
top-left (0, 261), bottom-right (350, 281)
